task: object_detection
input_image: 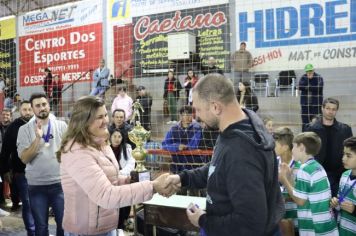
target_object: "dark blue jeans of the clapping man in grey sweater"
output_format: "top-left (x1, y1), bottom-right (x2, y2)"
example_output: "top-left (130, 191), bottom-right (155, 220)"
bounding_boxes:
top-left (28, 183), bottom-right (64, 236)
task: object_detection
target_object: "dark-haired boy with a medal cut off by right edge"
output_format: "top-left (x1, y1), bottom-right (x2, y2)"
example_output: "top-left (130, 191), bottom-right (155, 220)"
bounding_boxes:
top-left (331, 137), bottom-right (356, 236)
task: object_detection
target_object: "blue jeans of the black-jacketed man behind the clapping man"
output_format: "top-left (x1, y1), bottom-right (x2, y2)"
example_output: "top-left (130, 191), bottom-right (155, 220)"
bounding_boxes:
top-left (14, 173), bottom-right (35, 236)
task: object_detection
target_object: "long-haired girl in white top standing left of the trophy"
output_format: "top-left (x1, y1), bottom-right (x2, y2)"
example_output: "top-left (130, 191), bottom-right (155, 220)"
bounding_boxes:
top-left (110, 129), bottom-right (135, 229)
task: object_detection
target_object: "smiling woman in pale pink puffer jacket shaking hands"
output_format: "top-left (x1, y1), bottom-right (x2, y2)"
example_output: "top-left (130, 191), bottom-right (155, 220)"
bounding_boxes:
top-left (58, 96), bottom-right (170, 236)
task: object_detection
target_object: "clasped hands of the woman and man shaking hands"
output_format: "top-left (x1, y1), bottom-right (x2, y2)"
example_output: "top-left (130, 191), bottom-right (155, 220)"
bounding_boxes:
top-left (152, 173), bottom-right (181, 197)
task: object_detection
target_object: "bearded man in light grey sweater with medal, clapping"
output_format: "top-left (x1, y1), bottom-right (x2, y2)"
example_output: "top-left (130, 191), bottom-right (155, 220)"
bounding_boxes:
top-left (17, 93), bottom-right (67, 236)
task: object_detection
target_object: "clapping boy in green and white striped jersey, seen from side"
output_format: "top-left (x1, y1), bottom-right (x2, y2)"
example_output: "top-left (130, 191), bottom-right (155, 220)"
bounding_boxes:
top-left (280, 132), bottom-right (339, 236)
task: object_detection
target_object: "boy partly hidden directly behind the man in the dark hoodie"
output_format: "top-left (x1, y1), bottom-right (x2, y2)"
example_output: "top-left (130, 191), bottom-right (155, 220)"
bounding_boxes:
top-left (273, 127), bottom-right (300, 236)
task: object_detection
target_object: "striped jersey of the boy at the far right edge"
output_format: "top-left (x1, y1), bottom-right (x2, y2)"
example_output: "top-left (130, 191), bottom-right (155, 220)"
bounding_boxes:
top-left (339, 170), bottom-right (356, 236)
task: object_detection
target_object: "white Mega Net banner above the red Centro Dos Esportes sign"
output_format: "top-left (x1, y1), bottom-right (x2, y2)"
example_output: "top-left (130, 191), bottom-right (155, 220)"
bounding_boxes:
top-left (18, 0), bottom-right (103, 36)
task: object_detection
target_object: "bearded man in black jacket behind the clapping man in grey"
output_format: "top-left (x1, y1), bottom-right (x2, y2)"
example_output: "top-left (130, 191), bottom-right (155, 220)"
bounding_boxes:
top-left (0, 100), bottom-right (35, 236)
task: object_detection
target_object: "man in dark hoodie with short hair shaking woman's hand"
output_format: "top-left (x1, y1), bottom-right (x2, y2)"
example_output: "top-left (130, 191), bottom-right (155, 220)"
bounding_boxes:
top-left (166, 74), bottom-right (284, 236)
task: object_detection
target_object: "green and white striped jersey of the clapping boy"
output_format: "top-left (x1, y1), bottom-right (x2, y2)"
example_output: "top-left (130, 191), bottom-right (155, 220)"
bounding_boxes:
top-left (293, 158), bottom-right (339, 236)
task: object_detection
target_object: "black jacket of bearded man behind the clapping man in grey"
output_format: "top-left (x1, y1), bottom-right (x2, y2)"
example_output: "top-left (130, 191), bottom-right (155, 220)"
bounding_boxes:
top-left (0, 117), bottom-right (27, 174)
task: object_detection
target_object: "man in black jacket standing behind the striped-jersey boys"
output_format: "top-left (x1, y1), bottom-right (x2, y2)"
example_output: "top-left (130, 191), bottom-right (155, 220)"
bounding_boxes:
top-left (306, 98), bottom-right (352, 197)
